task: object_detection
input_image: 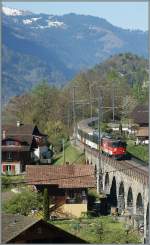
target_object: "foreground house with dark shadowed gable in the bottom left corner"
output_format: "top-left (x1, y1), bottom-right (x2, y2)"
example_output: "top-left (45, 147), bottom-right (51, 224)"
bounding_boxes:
top-left (1, 214), bottom-right (87, 244)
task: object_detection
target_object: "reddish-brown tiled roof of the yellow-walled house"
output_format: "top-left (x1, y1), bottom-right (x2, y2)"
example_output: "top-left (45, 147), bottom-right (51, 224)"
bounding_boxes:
top-left (26, 165), bottom-right (96, 188)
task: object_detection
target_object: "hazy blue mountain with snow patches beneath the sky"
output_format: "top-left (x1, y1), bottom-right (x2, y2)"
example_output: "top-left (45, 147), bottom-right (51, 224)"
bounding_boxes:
top-left (2, 7), bottom-right (148, 101)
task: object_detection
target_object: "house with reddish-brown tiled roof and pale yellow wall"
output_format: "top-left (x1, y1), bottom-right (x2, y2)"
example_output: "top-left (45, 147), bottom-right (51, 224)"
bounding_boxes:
top-left (26, 165), bottom-right (96, 217)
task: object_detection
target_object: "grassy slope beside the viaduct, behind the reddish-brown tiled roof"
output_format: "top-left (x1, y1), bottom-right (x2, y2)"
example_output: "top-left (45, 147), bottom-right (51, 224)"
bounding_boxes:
top-left (54, 143), bottom-right (85, 165)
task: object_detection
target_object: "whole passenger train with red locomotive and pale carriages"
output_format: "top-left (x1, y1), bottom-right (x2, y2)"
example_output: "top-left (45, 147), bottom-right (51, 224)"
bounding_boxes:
top-left (77, 120), bottom-right (127, 160)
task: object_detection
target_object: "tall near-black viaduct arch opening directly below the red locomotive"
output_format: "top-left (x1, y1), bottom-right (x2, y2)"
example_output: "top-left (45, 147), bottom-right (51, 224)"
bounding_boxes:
top-left (109, 176), bottom-right (118, 207)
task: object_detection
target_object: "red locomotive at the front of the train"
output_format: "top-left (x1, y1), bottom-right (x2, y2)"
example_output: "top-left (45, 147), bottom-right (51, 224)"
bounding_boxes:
top-left (101, 137), bottom-right (127, 159)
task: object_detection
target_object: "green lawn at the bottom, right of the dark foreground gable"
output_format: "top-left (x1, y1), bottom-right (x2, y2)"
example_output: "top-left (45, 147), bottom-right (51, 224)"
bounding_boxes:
top-left (52, 216), bottom-right (141, 244)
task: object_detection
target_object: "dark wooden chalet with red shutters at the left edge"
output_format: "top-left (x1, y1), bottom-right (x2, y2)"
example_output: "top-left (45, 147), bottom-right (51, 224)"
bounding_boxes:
top-left (2, 121), bottom-right (52, 174)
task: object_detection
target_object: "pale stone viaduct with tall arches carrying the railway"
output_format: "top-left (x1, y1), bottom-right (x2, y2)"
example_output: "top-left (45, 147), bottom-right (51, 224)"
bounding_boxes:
top-left (75, 143), bottom-right (149, 240)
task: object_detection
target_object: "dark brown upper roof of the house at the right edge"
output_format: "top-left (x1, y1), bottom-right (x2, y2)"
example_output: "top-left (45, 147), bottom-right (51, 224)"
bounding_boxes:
top-left (131, 105), bottom-right (149, 124)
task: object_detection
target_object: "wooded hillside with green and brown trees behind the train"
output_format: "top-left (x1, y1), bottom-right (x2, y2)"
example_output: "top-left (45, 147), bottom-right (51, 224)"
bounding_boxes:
top-left (3, 53), bottom-right (148, 142)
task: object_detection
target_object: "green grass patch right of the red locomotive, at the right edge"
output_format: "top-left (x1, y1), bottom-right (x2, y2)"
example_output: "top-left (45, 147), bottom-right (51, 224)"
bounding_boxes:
top-left (127, 140), bottom-right (149, 164)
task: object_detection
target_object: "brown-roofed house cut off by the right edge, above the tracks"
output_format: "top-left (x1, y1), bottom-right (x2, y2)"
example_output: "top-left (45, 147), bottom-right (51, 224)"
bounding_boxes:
top-left (131, 105), bottom-right (149, 144)
